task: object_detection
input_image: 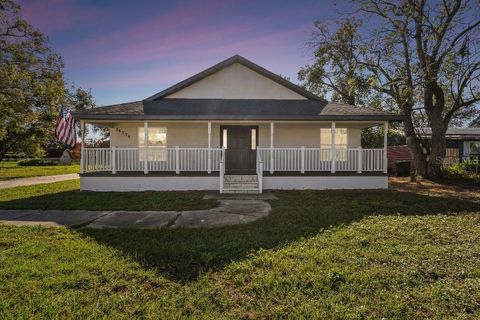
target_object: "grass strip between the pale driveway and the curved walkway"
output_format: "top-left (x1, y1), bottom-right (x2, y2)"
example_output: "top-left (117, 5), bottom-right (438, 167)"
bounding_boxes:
top-left (0, 180), bottom-right (218, 211)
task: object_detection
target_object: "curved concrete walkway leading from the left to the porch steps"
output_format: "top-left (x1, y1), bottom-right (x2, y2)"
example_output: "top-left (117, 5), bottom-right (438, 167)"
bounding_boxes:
top-left (0, 200), bottom-right (271, 229)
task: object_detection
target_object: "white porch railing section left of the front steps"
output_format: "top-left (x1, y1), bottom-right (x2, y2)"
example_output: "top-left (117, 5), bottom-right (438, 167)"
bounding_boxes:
top-left (82, 147), bottom-right (222, 173)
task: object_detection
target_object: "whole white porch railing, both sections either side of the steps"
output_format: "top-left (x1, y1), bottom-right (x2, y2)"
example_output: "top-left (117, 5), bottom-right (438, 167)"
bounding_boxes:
top-left (83, 147), bottom-right (386, 174)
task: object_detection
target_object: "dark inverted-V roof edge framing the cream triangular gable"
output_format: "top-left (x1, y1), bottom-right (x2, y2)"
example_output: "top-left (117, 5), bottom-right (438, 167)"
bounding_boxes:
top-left (145, 54), bottom-right (324, 101)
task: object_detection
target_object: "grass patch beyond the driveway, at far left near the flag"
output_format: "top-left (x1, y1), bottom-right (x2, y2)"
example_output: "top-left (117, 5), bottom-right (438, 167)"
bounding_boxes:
top-left (0, 161), bottom-right (80, 181)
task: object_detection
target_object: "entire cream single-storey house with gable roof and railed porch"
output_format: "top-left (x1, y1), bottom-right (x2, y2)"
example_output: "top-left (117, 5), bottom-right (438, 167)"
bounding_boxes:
top-left (74, 55), bottom-right (402, 193)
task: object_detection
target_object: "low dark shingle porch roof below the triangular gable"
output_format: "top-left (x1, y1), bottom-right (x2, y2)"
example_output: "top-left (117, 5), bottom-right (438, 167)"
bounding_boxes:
top-left (70, 99), bottom-right (403, 121)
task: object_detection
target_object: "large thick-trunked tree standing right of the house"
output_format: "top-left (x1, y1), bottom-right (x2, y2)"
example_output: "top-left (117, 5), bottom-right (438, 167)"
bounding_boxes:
top-left (307, 0), bottom-right (480, 178)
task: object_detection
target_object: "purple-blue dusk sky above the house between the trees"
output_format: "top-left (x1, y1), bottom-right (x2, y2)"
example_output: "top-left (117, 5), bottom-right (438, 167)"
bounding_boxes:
top-left (19, 0), bottom-right (337, 105)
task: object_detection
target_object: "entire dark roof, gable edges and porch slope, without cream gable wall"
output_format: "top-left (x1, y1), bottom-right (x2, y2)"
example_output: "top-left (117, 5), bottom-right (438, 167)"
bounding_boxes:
top-left (72, 55), bottom-right (404, 121)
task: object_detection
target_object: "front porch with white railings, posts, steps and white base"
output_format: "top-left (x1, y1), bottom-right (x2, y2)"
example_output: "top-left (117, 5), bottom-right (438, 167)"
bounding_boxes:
top-left (81, 121), bottom-right (388, 193)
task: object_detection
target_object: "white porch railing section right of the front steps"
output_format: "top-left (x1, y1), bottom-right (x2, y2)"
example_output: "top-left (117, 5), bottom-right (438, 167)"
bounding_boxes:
top-left (257, 147), bottom-right (386, 173)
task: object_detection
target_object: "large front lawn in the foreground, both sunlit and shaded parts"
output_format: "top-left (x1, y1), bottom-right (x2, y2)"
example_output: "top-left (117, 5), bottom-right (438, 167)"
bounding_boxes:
top-left (0, 181), bottom-right (480, 319)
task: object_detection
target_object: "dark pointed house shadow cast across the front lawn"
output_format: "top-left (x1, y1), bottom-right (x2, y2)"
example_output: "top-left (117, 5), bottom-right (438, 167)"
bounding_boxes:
top-left (79, 190), bottom-right (480, 282)
